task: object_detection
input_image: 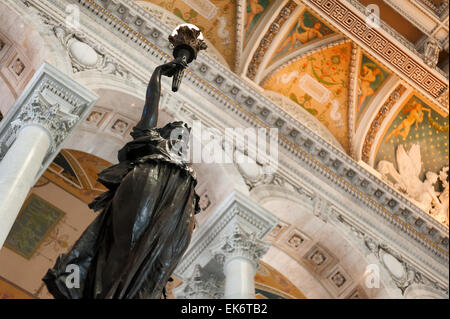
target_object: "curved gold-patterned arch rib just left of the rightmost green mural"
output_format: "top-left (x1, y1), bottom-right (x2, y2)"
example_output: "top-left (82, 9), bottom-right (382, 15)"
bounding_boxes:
top-left (361, 85), bottom-right (406, 164)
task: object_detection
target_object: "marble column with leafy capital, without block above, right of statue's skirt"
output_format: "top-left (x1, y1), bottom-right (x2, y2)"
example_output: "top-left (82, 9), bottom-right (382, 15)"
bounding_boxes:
top-left (215, 224), bottom-right (270, 299)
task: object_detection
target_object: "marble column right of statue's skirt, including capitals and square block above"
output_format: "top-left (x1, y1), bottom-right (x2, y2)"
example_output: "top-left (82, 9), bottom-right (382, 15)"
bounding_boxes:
top-left (174, 190), bottom-right (278, 299)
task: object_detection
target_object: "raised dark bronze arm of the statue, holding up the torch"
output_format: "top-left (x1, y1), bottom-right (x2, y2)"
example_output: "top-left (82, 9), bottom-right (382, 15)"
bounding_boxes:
top-left (136, 59), bottom-right (187, 130)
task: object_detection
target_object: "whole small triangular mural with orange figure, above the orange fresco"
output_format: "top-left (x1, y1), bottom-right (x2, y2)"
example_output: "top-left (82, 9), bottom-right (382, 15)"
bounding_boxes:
top-left (271, 10), bottom-right (335, 63)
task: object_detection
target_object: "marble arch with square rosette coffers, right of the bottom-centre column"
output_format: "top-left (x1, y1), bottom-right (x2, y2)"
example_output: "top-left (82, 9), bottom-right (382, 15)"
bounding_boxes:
top-left (250, 184), bottom-right (402, 299)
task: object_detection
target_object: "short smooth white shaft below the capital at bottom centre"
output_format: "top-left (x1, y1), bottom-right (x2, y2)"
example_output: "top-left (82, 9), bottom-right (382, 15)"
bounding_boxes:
top-left (224, 257), bottom-right (256, 299)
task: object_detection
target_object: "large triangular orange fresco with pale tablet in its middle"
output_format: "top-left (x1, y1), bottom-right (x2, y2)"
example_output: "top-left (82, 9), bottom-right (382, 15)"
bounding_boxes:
top-left (263, 43), bottom-right (352, 150)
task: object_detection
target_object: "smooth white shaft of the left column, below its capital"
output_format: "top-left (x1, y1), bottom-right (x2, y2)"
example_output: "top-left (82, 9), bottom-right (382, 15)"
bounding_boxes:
top-left (0, 125), bottom-right (50, 249)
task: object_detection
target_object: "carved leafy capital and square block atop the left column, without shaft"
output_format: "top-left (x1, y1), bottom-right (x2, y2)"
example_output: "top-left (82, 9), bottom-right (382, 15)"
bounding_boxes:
top-left (0, 62), bottom-right (98, 181)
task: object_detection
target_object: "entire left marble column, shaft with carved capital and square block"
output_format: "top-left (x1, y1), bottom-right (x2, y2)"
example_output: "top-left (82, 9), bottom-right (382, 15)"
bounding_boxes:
top-left (0, 63), bottom-right (97, 248)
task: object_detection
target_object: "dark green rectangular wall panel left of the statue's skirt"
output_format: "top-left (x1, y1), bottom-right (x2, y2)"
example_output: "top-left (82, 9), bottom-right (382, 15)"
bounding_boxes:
top-left (5, 194), bottom-right (65, 259)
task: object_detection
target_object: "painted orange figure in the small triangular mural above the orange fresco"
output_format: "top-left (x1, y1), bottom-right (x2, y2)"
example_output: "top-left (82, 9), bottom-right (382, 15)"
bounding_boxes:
top-left (275, 12), bottom-right (324, 54)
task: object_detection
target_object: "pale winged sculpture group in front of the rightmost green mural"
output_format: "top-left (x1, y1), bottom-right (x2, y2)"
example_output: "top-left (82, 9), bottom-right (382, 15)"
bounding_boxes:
top-left (377, 144), bottom-right (448, 225)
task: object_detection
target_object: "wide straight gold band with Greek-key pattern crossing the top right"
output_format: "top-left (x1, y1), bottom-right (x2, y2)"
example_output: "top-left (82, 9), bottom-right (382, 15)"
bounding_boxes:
top-left (303, 0), bottom-right (448, 112)
